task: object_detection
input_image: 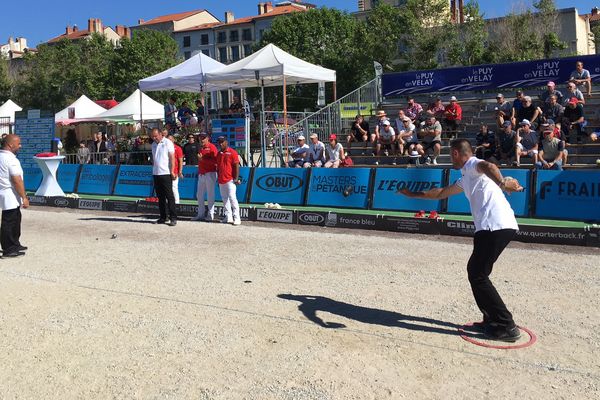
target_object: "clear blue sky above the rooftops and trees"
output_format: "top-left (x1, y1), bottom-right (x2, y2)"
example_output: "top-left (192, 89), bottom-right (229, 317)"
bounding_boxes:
top-left (0, 0), bottom-right (600, 47)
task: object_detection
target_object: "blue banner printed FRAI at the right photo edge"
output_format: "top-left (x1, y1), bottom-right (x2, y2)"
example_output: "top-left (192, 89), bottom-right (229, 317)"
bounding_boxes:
top-left (535, 170), bottom-right (600, 222)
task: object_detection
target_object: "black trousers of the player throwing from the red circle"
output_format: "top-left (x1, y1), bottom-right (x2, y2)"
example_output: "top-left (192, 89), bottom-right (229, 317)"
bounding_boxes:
top-left (467, 229), bottom-right (516, 328)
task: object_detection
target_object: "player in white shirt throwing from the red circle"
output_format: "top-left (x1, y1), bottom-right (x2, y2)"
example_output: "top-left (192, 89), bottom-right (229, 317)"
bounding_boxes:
top-left (400, 139), bottom-right (523, 342)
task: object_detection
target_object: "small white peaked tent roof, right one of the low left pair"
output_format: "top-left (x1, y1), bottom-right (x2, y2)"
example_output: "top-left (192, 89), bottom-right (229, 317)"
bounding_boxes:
top-left (93, 89), bottom-right (165, 121)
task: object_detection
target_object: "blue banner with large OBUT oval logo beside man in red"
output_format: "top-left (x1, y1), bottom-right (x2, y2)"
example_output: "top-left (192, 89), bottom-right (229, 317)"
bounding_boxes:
top-left (250, 168), bottom-right (308, 206)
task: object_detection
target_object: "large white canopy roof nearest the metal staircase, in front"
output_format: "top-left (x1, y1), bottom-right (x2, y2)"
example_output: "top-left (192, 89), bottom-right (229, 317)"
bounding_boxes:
top-left (206, 44), bottom-right (336, 89)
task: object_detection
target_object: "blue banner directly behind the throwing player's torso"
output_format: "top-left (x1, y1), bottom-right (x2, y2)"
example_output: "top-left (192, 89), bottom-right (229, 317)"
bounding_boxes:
top-left (447, 169), bottom-right (531, 217)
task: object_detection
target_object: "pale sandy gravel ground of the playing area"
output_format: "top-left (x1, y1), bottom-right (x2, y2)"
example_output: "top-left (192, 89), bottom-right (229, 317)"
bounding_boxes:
top-left (0, 208), bottom-right (600, 400)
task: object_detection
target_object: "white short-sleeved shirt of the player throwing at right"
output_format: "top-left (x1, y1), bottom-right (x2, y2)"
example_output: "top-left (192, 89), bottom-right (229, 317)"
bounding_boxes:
top-left (456, 157), bottom-right (519, 232)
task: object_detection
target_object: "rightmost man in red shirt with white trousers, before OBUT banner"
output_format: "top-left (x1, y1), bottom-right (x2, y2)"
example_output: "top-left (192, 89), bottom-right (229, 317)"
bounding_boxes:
top-left (217, 136), bottom-right (242, 225)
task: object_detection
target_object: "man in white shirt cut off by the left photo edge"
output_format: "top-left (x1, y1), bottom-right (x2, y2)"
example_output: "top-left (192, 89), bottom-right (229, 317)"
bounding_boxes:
top-left (0, 135), bottom-right (29, 258)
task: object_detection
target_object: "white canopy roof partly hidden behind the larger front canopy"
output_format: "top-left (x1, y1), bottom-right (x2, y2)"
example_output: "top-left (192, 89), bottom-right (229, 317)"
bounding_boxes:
top-left (139, 53), bottom-right (225, 93)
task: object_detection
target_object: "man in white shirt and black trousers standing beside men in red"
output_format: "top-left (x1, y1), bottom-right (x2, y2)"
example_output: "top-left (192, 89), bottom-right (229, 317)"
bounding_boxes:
top-left (152, 129), bottom-right (178, 226)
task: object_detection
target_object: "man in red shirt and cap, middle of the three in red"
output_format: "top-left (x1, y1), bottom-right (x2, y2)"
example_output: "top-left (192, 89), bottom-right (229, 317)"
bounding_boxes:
top-left (192, 132), bottom-right (218, 222)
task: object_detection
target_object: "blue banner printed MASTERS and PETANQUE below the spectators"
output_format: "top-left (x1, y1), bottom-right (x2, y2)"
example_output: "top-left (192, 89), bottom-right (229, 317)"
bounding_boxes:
top-left (306, 168), bottom-right (371, 208)
